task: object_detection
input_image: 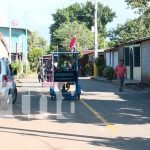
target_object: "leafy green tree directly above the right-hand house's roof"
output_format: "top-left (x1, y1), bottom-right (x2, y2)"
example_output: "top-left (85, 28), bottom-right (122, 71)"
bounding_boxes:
top-left (109, 18), bottom-right (150, 46)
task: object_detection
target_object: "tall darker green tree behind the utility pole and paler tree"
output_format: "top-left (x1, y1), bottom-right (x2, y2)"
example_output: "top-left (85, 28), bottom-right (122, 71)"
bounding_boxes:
top-left (50, 1), bottom-right (115, 47)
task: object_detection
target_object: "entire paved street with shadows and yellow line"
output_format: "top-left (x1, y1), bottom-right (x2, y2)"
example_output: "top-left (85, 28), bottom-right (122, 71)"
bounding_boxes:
top-left (0, 76), bottom-right (150, 150)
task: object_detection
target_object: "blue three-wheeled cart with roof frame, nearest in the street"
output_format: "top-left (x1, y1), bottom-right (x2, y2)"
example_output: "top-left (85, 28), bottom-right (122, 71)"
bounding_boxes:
top-left (50, 52), bottom-right (81, 100)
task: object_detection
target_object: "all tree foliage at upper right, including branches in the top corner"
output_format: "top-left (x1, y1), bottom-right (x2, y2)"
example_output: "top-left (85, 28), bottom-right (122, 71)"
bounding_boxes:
top-left (108, 0), bottom-right (150, 47)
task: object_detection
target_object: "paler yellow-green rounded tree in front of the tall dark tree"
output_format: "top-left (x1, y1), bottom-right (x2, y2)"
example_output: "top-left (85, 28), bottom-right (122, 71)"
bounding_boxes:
top-left (54, 21), bottom-right (94, 51)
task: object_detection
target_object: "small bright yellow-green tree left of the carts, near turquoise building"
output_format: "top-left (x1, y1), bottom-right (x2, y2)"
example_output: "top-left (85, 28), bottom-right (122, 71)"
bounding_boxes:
top-left (28, 48), bottom-right (42, 71)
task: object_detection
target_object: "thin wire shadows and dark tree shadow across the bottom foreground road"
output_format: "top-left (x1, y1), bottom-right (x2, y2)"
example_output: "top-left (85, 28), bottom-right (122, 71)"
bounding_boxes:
top-left (0, 127), bottom-right (150, 150)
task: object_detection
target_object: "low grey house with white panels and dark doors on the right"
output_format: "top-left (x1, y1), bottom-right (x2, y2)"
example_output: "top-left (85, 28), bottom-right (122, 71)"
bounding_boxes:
top-left (105, 37), bottom-right (150, 85)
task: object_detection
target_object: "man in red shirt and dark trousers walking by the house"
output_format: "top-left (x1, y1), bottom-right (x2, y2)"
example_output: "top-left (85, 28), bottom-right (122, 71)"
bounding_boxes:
top-left (114, 60), bottom-right (127, 92)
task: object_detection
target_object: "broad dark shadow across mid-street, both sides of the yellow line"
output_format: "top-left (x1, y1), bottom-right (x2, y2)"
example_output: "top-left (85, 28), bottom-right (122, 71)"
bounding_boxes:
top-left (3, 77), bottom-right (150, 125)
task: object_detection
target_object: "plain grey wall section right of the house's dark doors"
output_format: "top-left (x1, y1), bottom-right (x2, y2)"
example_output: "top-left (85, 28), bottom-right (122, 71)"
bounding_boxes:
top-left (141, 40), bottom-right (150, 85)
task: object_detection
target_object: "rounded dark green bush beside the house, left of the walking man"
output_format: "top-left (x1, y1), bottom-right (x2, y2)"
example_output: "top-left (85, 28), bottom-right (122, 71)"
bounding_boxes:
top-left (103, 67), bottom-right (114, 80)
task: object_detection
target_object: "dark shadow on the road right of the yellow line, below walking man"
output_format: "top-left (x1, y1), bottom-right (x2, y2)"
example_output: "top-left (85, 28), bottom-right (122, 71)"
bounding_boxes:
top-left (80, 80), bottom-right (150, 124)
